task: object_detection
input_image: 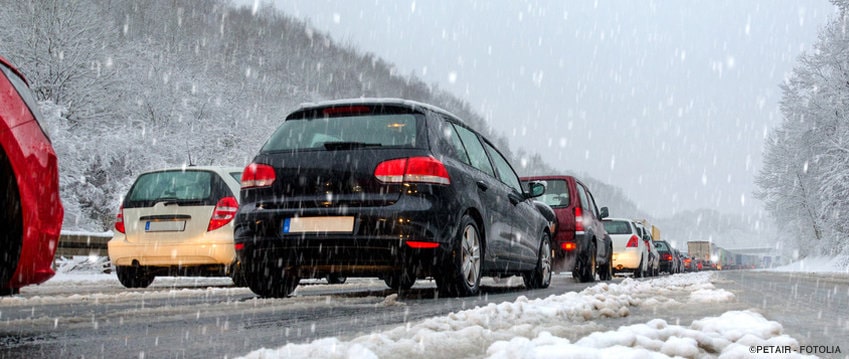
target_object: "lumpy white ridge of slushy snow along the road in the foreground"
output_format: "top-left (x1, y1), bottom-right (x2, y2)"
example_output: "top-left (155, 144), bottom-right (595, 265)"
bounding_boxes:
top-left (237, 272), bottom-right (801, 359)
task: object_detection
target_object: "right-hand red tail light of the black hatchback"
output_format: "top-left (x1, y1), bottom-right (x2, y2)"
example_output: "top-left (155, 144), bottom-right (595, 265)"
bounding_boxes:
top-left (374, 157), bottom-right (451, 185)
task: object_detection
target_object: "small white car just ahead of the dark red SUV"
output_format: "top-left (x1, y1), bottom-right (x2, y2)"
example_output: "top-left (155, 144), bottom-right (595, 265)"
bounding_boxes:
top-left (602, 218), bottom-right (651, 278)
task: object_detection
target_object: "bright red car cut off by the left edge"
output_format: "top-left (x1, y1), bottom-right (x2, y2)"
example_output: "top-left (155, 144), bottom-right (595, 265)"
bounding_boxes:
top-left (0, 57), bottom-right (64, 295)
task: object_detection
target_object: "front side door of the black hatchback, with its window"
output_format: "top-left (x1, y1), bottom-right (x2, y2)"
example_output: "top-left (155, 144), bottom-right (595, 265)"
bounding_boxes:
top-left (484, 142), bottom-right (540, 263)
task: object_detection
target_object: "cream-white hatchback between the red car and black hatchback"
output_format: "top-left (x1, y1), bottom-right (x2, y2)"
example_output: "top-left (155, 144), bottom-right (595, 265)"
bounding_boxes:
top-left (108, 166), bottom-right (244, 288)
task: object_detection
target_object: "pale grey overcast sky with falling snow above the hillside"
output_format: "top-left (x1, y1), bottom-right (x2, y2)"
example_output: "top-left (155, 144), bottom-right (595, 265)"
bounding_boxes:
top-left (237, 0), bottom-right (834, 217)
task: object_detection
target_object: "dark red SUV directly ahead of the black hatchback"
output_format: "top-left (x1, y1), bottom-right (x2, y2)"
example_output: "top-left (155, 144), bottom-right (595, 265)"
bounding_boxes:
top-left (521, 175), bottom-right (613, 282)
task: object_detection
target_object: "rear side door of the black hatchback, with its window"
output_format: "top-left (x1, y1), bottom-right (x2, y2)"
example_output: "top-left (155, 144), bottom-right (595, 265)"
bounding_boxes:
top-left (454, 123), bottom-right (513, 267)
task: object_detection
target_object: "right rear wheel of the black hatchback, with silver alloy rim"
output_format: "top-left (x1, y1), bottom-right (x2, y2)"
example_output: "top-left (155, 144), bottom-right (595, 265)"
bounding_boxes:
top-left (436, 215), bottom-right (483, 297)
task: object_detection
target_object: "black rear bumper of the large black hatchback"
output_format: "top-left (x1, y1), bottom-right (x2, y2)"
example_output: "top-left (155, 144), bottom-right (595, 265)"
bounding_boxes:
top-left (235, 197), bottom-right (458, 276)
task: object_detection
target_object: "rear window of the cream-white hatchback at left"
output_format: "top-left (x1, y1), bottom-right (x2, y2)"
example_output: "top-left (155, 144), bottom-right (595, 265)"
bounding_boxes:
top-left (127, 171), bottom-right (213, 207)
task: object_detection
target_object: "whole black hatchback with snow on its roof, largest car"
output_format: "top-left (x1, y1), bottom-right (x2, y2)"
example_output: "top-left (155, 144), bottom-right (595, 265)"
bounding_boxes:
top-left (235, 99), bottom-right (552, 297)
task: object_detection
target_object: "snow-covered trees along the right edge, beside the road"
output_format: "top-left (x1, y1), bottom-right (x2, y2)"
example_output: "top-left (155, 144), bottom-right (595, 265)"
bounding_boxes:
top-left (757, 0), bottom-right (849, 257)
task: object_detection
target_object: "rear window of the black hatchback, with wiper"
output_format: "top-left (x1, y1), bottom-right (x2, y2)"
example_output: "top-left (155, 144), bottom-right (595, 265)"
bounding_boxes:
top-left (262, 114), bottom-right (421, 152)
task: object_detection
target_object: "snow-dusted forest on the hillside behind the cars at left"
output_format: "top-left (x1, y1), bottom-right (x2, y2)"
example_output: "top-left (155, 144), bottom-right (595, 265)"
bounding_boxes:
top-left (0, 0), bottom-right (638, 231)
